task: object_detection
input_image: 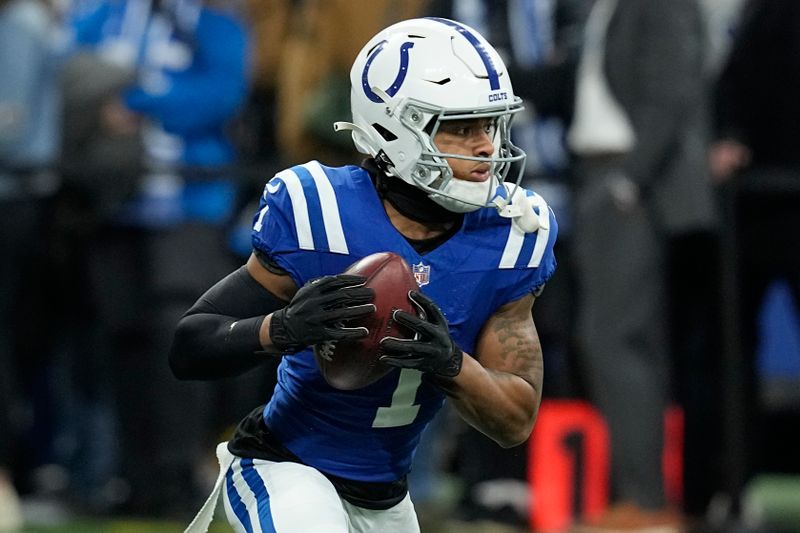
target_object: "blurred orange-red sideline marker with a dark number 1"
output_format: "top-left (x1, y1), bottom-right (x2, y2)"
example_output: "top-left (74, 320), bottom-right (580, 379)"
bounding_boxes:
top-left (528, 400), bottom-right (610, 532)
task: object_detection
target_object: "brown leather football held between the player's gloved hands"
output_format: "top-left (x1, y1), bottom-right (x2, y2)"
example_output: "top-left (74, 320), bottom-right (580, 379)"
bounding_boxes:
top-left (314, 252), bottom-right (419, 390)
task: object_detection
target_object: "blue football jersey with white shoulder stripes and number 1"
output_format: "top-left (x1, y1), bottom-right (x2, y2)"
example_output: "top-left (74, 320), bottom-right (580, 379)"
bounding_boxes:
top-left (252, 161), bottom-right (557, 482)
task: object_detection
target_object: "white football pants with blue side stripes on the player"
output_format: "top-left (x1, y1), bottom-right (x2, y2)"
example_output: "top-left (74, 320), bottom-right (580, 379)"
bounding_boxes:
top-left (186, 443), bottom-right (419, 533)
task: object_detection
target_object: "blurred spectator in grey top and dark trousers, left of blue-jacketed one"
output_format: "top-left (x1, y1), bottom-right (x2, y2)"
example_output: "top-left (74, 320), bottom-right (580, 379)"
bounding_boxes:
top-left (24, 9), bottom-right (142, 511)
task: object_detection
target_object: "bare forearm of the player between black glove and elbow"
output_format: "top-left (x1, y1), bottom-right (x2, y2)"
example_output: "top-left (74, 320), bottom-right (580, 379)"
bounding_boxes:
top-left (440, 354), bottom-right (542, 448)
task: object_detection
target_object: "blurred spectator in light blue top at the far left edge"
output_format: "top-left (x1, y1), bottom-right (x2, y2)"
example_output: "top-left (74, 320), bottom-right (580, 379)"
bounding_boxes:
top-left (0, 0), bottom-right (60, 531)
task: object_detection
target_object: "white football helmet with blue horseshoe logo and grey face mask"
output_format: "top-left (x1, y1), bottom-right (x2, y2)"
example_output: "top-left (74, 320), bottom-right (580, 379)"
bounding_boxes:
top-left (334, 18), bottom-right (525, 216)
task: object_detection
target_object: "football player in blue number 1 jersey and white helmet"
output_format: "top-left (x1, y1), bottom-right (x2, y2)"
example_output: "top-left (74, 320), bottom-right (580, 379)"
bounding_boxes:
top-left (170, 18), bottom-right (558, 533)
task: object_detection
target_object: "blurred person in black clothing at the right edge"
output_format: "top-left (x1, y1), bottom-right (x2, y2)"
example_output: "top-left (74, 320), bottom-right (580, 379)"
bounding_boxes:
top-left (710, 0), bottom-right (800, 504)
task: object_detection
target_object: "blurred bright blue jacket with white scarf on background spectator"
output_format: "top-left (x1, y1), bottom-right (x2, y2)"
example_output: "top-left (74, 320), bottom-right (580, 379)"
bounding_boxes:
top-left (70, 0), bottom-right (250, 229)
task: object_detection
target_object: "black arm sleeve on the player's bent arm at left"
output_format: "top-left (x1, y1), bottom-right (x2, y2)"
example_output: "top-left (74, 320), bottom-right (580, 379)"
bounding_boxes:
top-left (169, 266), bottom-right (287, 380)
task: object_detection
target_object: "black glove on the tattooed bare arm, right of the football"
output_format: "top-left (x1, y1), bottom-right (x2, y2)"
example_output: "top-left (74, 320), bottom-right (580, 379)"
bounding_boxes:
top-left (381, 291), bottom-right (464, 378)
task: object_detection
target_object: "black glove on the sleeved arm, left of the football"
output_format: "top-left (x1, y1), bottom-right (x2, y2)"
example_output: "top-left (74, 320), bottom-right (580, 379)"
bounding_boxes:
top-left (269, 274), bottom-right (375, 353)
